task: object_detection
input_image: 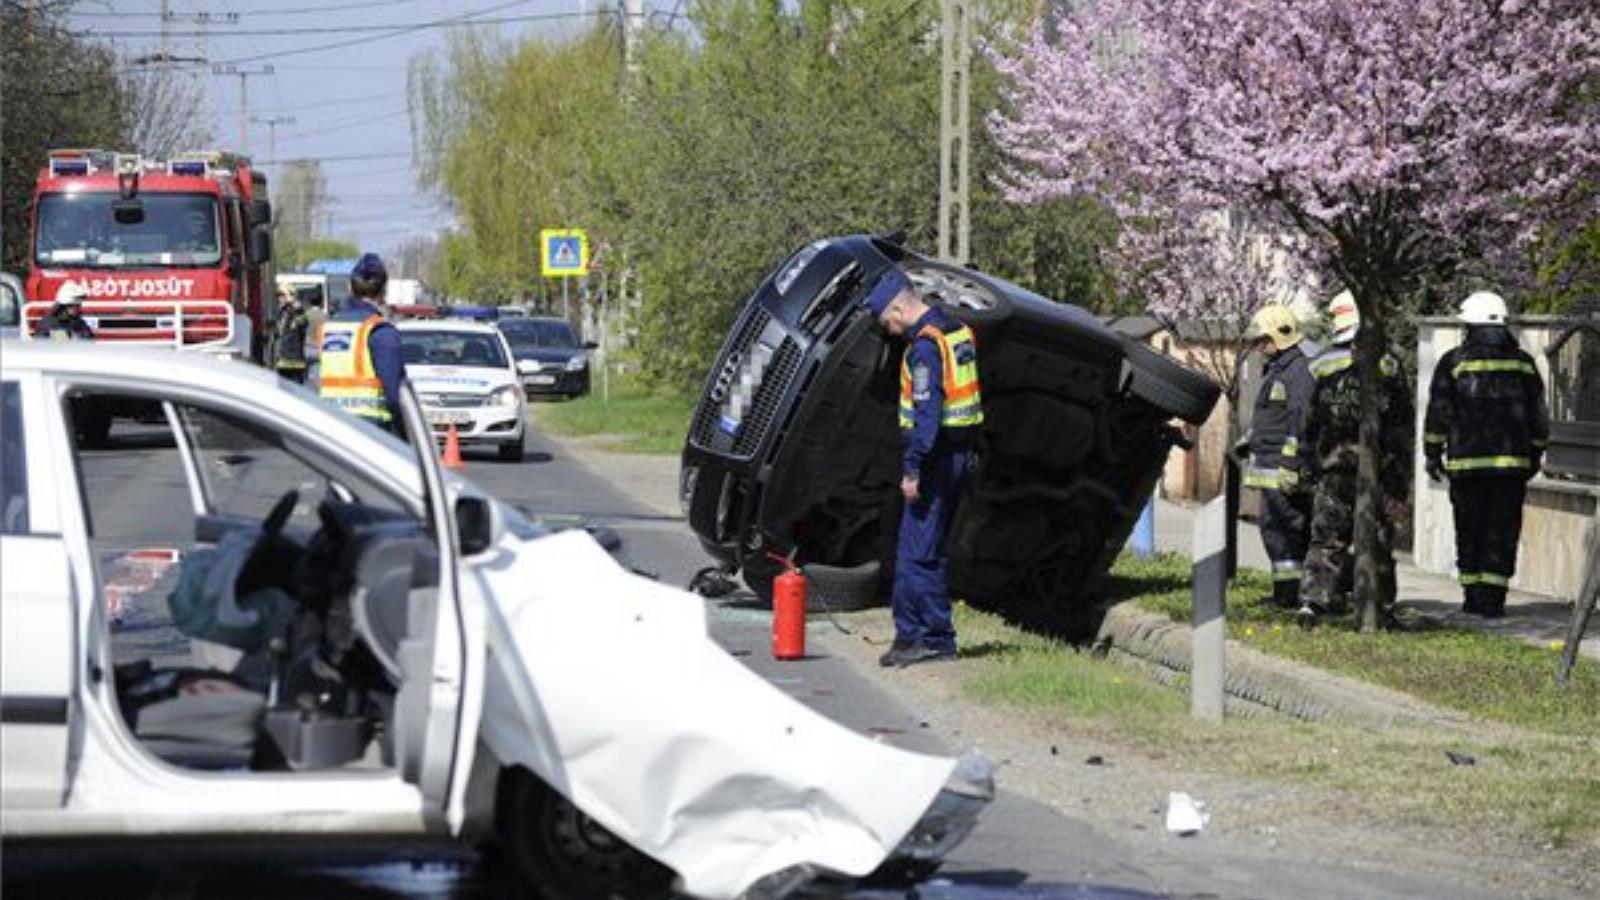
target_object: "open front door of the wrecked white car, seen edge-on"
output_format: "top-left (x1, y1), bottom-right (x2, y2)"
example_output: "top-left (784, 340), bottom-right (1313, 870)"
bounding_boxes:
top-left (394, 381), bottom-right (483, 833)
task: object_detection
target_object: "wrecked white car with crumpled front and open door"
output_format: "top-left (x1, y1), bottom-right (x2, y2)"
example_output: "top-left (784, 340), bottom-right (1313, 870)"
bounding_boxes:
top-left (0, 341), bottom-right (994, 898)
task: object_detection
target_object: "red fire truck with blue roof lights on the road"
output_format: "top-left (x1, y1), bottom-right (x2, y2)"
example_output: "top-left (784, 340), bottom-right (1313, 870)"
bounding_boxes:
top-left (22, 151), bottom-right (272, 362)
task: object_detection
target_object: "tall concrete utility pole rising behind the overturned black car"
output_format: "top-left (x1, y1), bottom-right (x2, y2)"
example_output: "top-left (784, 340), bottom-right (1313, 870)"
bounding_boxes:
top-left (939, 0), bottom-right (973, 264)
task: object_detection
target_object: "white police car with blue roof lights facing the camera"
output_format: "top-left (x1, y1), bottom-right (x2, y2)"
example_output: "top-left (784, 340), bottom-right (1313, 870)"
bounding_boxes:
top-left (395, 319), bottom-right (528, 463)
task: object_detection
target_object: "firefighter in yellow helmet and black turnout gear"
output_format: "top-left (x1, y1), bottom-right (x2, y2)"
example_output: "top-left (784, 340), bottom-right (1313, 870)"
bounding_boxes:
top-left (1245, 304), bottom-right (1315, 610)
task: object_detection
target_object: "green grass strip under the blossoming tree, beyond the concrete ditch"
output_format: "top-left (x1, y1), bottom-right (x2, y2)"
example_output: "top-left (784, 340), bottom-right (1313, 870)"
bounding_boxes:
top-left (1112, 556), bottom-right (1600, 735)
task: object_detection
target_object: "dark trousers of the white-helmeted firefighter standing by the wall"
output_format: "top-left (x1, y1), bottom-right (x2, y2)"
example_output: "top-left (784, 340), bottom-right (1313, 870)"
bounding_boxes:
top-left (1450, 472), bottom-right (1528, 617)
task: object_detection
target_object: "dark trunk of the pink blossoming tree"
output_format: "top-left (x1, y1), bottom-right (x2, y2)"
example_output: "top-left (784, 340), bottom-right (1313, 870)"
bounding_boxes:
top-left (1354, 296), bottom-right (1392, 633)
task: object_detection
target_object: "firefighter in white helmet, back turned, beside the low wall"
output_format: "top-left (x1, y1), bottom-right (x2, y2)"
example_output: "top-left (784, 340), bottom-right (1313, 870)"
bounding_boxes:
top-left (1422, 291), bottom-right (1550, 618)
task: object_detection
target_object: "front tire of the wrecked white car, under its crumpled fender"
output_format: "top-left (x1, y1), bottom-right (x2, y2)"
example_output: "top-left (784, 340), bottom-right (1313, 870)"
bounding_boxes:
top-left (498, 769), bottom-right (674, 900)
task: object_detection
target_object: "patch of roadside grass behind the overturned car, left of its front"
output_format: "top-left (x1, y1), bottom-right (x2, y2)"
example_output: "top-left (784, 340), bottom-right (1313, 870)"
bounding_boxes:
top-left (533, 378), bottom-right (696, 455)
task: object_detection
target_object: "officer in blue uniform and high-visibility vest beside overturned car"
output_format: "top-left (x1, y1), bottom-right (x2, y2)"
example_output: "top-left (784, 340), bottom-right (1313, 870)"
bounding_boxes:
top-left (862, 267), bottom-right (984, 666)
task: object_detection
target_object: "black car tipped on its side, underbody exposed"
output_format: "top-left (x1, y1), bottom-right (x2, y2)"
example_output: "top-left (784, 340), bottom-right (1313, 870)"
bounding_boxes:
top-left (680, 235), bottom-right (1219, 639)
